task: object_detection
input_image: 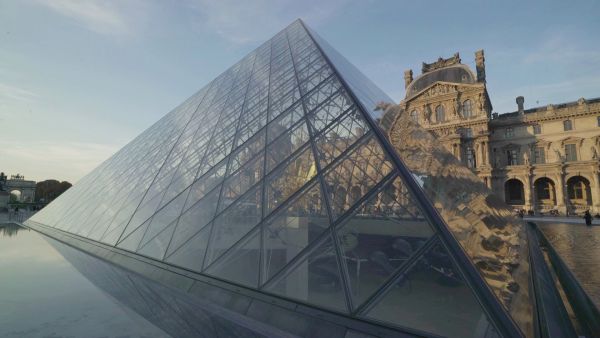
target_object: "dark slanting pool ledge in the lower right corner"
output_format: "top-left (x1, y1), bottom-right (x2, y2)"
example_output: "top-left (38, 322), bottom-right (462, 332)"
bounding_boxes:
top-left (528, 222), bottom-right (600, 337)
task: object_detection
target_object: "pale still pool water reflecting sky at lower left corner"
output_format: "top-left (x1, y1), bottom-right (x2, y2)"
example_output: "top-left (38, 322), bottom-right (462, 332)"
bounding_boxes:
top-left (0, 224), bottom-right (169, 338)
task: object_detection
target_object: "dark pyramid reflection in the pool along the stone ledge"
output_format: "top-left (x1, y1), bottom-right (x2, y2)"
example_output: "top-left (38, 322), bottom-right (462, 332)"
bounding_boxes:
top-left (44, 236), bottom-right (290, 337)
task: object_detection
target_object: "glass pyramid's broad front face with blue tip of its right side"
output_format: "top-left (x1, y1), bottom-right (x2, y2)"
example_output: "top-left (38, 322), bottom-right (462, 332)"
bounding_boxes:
top-left (28, 20), bottom-right (520, 337)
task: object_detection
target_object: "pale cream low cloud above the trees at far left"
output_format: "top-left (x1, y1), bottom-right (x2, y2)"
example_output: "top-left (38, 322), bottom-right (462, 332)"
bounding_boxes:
top-left (0, 140), bottom-right (120, 183)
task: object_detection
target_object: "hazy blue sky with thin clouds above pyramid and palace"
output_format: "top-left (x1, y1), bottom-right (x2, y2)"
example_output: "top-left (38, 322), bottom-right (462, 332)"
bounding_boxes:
top-left (0, 0), bottom-right (600, 182)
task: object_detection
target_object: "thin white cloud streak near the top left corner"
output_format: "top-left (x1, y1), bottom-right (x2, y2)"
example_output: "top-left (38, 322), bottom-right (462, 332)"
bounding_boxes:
top-left (38, 0), bottom-right (133, 36)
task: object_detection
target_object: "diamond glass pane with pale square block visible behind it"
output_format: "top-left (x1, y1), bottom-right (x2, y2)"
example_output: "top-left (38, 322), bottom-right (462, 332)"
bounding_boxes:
top-left (261, 183), bottom-right (329, 283)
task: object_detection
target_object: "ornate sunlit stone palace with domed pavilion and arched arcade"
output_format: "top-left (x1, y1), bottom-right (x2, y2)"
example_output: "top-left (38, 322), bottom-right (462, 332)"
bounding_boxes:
top-left (400, 50), bottom-right (600, 215)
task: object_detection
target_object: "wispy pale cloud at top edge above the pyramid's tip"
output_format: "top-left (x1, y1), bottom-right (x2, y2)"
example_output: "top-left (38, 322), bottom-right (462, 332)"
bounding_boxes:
top-left (187, 0), bottom-right (351, 44)
